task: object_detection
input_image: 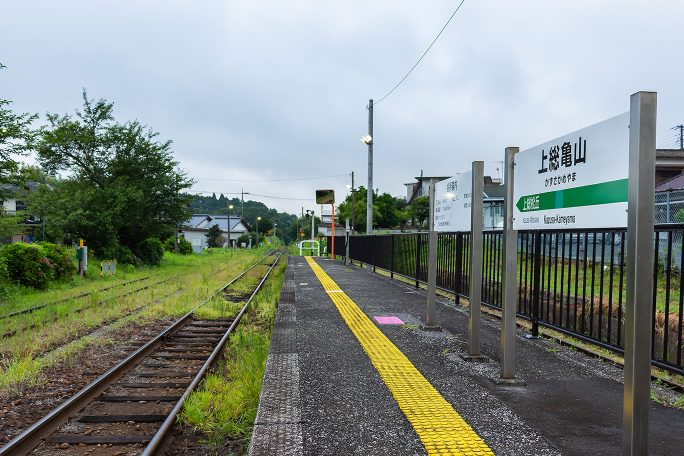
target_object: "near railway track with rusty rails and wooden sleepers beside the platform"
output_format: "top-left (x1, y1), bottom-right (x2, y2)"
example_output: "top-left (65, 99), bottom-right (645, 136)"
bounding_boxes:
top-left (0, 251), bottom-right (284, 456)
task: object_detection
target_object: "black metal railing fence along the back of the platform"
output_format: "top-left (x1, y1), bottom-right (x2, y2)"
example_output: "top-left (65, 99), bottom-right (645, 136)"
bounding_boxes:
top-left (328, 224), bottom-right (684, 374)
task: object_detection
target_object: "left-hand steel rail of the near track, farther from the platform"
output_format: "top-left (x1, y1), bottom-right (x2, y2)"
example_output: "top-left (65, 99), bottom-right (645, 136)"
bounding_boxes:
top-left (0, 252), bottom-right (282, 456)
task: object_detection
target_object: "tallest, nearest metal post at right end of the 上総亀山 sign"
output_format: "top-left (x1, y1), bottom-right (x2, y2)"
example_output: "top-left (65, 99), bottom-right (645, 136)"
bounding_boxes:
top-left (623, 92), bottom-right (657, 456)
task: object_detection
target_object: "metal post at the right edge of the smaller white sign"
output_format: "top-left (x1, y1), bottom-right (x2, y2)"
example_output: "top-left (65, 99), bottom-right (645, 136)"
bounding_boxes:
top-left (464, 161), bottom-right (487, 361)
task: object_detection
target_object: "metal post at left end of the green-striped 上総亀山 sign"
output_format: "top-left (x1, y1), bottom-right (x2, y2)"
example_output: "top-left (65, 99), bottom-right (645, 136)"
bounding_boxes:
top-left (500, 147), bottom-right (518, 382)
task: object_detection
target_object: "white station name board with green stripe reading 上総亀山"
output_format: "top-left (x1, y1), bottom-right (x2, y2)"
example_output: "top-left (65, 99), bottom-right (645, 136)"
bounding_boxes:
top-left (513, 113), bottom-right (629, 230)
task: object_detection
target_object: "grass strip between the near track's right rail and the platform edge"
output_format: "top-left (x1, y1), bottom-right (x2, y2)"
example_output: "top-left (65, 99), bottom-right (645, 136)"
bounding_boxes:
top-left (179, 257), bottom-right (287, 453)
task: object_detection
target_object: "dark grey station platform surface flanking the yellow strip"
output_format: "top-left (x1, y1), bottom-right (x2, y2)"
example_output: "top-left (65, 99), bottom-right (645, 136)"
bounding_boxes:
top-left (250, 257), bottom-right (684, 455)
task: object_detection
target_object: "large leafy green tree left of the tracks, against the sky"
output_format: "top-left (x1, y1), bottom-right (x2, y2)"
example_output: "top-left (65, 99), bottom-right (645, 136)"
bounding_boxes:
top-left (31, 90), bottom-right (192, 257)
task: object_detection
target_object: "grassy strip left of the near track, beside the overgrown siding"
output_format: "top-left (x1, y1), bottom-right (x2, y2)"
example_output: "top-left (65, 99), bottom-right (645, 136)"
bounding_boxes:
top-left (0, 249), bottom-right (265, 394)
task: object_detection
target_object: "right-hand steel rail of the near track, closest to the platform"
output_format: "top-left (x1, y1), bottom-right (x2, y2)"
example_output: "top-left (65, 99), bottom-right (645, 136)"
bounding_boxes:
top-left (141, 250), bottom-right (285, 456)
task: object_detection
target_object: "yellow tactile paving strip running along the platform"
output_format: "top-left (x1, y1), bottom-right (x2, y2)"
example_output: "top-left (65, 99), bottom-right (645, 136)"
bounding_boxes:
top-left (305, 257), bottom-right (494, 455)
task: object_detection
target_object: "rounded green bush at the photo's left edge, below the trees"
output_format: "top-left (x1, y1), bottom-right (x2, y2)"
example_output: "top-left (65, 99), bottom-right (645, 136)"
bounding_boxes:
top-left (2, 243), bottom-right (55, 288)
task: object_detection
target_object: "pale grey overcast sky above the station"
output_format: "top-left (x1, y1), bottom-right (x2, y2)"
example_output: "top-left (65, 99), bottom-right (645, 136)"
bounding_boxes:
top-left (0, 0), bottom-right (684, 213)
